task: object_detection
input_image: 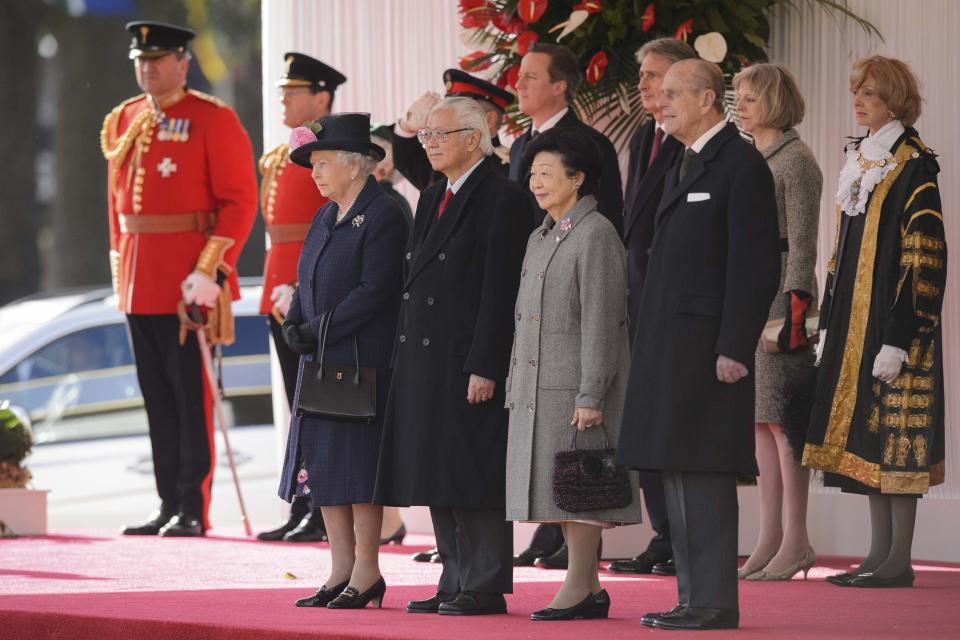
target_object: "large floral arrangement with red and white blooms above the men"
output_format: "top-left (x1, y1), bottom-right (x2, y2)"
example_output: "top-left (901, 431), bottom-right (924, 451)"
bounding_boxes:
top-left (459, 0), bottom-right (879, 146)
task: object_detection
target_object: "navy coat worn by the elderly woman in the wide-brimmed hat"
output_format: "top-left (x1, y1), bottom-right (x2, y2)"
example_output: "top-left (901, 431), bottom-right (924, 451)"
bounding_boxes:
top-left (279, 177), bottom-right (407, 505)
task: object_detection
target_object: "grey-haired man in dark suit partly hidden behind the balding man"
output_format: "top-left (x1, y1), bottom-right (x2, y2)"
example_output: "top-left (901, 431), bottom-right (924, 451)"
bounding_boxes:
top-left (610, 38), bottom-right (697, 575)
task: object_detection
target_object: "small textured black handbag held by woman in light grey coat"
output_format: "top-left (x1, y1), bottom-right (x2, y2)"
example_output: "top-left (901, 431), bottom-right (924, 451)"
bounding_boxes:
top-left (553, 425), bottom-right (633, 513)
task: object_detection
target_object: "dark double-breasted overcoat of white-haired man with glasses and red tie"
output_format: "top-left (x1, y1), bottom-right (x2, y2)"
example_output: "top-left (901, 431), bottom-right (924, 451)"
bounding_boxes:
top-left (375, 162), bottom-right (533, 509)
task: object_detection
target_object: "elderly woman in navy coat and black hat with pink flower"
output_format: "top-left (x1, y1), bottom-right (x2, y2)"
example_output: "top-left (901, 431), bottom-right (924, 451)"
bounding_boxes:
top-left (280, 113), bottom-right (407, 609)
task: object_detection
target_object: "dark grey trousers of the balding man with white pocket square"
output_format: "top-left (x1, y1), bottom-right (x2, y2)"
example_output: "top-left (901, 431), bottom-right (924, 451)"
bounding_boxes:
top-left (663, 471), bottom-right (739, 611)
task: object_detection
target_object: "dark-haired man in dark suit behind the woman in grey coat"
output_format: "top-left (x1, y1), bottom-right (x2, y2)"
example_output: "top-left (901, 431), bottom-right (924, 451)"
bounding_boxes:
top-left (510, 42), bottom-right (623, 235)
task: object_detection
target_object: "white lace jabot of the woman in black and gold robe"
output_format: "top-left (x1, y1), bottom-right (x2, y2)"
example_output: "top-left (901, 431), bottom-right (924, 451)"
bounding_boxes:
top-left (837, 120), bottom-right (906, 216)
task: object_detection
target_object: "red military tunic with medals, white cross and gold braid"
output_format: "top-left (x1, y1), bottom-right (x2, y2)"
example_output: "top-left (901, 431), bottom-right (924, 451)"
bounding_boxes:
top-left (101, 90), bottom-right (257, 314)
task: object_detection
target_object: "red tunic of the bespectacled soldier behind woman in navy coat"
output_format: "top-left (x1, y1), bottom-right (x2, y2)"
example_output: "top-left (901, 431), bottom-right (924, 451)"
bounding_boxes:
top-left (260, 144), bottom-right (328, 314)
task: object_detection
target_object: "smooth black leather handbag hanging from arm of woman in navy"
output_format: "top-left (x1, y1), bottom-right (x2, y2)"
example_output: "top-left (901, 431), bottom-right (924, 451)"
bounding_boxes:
top-left (296, 311), bottom-right (377, 423)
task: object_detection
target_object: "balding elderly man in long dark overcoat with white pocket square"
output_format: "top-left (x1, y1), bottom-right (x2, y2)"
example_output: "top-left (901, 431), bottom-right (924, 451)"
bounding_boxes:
top-left (617, 59), bottom-right (780, 629)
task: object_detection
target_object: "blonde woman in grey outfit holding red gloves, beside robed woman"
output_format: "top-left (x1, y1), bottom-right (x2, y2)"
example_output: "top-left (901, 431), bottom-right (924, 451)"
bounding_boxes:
top-left (733, 64), bottom-right (823, 580)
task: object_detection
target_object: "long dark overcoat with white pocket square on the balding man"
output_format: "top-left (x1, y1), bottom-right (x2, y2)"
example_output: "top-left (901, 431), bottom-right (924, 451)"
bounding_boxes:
top-left (617, 124), bottom-right (780, 474)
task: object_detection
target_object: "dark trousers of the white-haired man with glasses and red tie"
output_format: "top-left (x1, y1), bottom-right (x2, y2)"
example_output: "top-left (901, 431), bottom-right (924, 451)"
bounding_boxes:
top-left (430, 507), bottom-right (513, 595)
